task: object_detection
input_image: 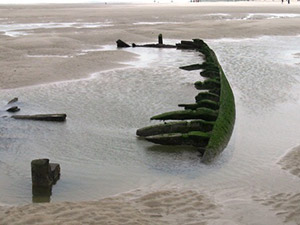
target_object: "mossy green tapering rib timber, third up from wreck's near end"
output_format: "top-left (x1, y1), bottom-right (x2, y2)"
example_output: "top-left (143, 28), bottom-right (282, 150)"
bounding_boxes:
top-left (151, 107), bottom-right (218, 121)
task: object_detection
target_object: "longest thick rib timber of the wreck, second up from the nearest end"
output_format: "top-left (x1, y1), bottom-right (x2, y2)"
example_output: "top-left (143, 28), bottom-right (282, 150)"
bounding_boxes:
top-left (136, 120), bottom-right (214, 137)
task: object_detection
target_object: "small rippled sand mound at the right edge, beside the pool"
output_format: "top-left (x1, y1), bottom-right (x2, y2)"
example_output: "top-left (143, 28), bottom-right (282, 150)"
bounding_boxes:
top-left (278, 145), bottom-right (300, 178)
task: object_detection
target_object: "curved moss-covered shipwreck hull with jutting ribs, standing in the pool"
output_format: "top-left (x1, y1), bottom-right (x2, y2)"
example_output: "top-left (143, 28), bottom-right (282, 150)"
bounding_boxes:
top-left (125, 39), bottom-right (235, 163)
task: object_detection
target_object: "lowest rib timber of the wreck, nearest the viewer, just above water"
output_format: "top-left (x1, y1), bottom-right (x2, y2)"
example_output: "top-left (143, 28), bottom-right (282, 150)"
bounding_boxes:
top-left (145, 131), bottom-right (210, 147)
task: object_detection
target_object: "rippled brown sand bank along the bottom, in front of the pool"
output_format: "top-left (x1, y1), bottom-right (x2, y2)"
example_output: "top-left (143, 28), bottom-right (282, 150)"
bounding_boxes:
top-left (0, 189), bottom-right (219, 225)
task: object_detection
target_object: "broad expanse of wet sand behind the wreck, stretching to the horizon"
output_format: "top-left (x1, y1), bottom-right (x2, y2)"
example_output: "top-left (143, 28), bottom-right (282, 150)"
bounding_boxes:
top-left (0, 2), bottom-right (300, 89)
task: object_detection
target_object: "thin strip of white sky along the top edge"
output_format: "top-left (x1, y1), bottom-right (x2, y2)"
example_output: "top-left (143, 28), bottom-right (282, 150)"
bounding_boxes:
top-left (0, 0), bottom-right (189, 4)
